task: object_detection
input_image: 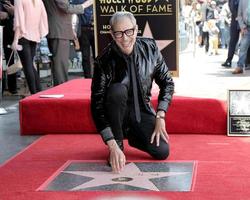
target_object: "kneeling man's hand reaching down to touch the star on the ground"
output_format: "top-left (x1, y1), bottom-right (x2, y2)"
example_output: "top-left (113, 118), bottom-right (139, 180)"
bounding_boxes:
top-left (107, 140), bottom-right (126, 173)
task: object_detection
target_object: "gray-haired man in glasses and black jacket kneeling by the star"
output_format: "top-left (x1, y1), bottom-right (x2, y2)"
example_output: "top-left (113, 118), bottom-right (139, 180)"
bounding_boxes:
top-left (91, 12), bottom-right (174, 172)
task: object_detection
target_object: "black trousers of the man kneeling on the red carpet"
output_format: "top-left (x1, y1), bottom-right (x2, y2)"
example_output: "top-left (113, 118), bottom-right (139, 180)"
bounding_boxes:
top-left (106, 83), bottom-right (169, 160)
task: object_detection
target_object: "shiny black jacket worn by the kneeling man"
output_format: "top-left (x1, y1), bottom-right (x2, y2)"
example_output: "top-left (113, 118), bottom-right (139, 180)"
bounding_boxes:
top-left (91, 37), bottom-right (174, 141)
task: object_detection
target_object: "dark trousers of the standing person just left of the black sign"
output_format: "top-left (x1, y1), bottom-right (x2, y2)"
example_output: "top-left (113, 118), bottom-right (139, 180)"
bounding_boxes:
top-left (78, 26), bottom-right (95, 78)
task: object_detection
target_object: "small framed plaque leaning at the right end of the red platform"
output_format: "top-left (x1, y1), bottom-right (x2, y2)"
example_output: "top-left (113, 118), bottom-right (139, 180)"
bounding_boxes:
top-left (227, 90), bottom-right (250, 136)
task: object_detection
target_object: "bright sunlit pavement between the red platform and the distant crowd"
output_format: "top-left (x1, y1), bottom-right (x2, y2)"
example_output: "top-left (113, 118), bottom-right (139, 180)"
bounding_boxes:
top-left (174, 45), bottom-right (250, 100)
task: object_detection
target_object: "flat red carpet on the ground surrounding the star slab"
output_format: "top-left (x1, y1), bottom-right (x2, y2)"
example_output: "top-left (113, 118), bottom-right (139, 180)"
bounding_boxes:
top-left (0, 134), bottom-right (250, 200)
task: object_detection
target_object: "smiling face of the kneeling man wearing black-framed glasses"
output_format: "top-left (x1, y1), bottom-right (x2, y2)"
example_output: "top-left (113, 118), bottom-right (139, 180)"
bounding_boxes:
top-left (111, 18), bottom-right (138, 55)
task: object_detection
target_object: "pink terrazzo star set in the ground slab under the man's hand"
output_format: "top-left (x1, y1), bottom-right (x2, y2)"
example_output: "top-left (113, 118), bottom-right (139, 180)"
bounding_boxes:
top-left (64, 163), bottom-right (190, 191)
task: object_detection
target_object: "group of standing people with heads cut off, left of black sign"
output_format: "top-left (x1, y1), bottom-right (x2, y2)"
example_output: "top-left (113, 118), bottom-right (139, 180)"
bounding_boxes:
top-left (0, 0), bottom-right (94, 94)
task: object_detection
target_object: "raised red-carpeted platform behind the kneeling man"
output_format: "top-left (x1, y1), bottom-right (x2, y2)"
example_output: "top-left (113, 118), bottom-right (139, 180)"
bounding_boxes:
top-left (20, 79), bottom-right (227, 135)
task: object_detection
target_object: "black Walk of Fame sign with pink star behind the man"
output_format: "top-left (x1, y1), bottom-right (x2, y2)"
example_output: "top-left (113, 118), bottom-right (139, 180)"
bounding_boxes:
top-left (94, 0), bottom-right (179, 76)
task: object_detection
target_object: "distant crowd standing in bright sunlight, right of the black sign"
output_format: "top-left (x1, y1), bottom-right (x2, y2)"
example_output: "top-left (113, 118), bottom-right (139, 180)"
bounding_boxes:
top-left (182, 0), bottom-right (250, 74)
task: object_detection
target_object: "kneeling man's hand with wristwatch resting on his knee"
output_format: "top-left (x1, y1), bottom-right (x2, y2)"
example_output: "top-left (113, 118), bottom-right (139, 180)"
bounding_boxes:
top-left (150, 112), bottom-right (169, 146)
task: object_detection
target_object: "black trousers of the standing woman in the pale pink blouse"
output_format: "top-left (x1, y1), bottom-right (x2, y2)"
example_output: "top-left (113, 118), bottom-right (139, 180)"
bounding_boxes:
top-left (18, 38), bottom-right (41, 94)
